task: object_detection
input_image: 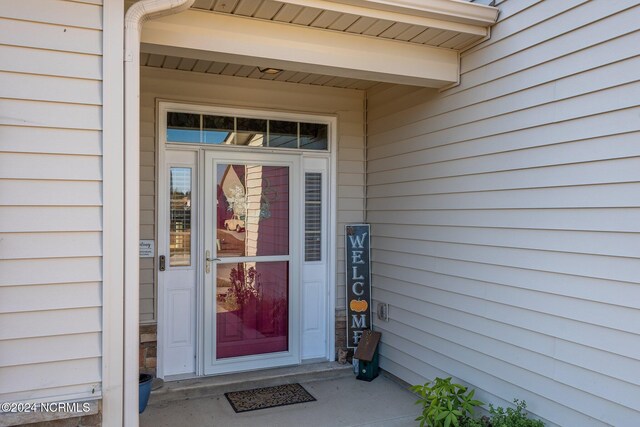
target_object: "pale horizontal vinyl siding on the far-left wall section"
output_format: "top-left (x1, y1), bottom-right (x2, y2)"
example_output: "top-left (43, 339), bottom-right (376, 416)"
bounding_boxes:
top-left (0, 0), bottom-right (102, 402)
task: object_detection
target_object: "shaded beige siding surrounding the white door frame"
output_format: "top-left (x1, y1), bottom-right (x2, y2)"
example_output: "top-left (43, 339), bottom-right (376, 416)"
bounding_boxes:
top-left (140, 67), bottom-right (364, 322)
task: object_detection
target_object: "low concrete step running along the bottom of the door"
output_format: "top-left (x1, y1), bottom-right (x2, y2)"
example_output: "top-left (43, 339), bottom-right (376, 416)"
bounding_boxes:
top-left (149, 362), bottom-right (353, 405)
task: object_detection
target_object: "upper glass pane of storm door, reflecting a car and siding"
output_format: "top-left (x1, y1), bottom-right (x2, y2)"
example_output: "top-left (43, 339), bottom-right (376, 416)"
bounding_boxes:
top-left (216, 164), bottom-right (289, 257)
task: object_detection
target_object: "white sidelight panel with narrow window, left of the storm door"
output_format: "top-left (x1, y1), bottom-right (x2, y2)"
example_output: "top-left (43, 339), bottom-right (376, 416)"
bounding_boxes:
top-left (158, 150), bottom-right (200, 378)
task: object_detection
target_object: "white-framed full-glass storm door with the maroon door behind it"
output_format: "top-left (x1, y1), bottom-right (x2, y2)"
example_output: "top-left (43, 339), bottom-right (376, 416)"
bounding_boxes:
top-left (203, 150), bottom-right (302, 374)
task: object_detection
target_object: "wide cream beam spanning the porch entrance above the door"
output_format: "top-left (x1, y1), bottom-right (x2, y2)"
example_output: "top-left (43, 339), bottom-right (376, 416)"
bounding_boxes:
top-left (142, 10), bottom-right (459, 88)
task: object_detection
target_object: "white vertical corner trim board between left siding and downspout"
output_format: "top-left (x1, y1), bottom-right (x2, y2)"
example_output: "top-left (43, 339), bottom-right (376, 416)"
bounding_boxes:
top-left (102, 0), bottom-right (124, 427)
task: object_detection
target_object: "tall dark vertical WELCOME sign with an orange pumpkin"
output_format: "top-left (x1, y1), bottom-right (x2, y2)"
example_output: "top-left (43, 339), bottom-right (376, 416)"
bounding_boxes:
top-left (345, 224), bottom-right (371, 348)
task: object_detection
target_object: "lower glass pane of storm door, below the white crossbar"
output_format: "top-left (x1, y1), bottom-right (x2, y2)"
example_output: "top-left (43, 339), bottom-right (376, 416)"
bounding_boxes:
top-left (215, 261), bottom-right (289, 359)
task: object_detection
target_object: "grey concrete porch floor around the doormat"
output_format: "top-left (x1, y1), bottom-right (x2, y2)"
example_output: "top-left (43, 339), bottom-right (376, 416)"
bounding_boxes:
top-left (140, 373), bottom-right (419, 427)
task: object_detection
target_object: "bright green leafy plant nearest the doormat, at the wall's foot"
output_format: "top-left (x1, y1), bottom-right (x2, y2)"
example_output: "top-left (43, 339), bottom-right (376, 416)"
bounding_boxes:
top-left (411, 377), bottom-right (483, 427)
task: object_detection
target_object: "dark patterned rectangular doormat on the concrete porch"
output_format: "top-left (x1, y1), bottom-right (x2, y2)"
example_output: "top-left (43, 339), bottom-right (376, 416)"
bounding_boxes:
top-left (224, 383), bottom-right (316, 413)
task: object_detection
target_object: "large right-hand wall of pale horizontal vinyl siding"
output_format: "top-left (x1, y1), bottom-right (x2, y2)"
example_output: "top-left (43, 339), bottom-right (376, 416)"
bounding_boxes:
top-left (367, 0), bottom-right (640, 426)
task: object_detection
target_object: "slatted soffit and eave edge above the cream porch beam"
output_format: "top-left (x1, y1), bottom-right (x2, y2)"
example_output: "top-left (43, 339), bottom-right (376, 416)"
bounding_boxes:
top-left (188, 0), bottom-right (498, 50)
